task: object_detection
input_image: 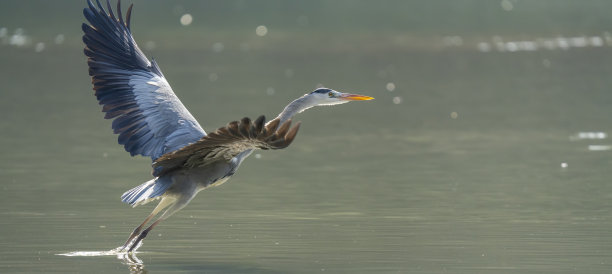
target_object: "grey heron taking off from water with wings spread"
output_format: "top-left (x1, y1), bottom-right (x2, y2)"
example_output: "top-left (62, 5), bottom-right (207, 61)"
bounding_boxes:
top-left (82, 0), bottom-right (374, 252)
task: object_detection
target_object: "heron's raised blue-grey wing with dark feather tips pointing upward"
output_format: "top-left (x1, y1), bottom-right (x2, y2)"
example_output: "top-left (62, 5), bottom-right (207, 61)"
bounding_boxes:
top-left (82, 0), bottom-right (206, 160)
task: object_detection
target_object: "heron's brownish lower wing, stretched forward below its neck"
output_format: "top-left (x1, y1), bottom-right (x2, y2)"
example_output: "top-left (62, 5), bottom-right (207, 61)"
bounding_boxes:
top-left (153, 115), bottom-right (300, 176)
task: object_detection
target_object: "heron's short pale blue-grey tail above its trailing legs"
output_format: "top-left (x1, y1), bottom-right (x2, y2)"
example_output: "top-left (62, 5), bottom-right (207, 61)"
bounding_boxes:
top-left (121, 177), bottom-right (172, 207)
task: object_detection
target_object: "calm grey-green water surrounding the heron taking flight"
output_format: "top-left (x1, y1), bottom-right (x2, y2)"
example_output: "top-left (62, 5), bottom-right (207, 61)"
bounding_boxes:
top-left (0, 1), bottom-right (612, 273)
